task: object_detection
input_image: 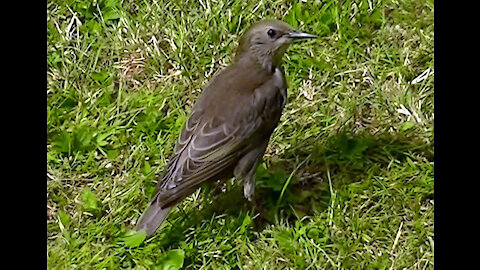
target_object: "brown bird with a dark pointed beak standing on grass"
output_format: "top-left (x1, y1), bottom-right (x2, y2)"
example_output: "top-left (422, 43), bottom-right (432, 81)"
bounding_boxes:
top-left (136, 19), bottom-right (317, 236)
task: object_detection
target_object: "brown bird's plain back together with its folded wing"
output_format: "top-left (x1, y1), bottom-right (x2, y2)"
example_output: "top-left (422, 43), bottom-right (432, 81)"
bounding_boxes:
top-left (148, 63), bottom-right (285, 207)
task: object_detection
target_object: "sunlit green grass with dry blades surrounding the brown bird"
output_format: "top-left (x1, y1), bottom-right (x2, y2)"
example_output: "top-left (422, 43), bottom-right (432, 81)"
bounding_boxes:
top-left (47, 0), bottom-right (434, 269)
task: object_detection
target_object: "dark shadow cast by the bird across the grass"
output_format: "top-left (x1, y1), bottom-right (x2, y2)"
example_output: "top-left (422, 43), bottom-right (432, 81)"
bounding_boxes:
top-left (153, 133), bottom-right (434, 245)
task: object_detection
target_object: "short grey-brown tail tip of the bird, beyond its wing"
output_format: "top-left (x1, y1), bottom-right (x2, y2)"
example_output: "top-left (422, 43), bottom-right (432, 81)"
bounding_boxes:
top-left (137, 201), bottom-right (172, 236)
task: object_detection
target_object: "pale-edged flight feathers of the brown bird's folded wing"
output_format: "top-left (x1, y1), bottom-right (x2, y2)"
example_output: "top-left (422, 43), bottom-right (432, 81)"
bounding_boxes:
top-left (152, 104), bottom-right (259, 207)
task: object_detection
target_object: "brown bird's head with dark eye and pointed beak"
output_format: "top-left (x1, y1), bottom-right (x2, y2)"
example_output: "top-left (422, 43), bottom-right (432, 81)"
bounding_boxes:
top-left (236, 20), bottom-right (316, 67)
